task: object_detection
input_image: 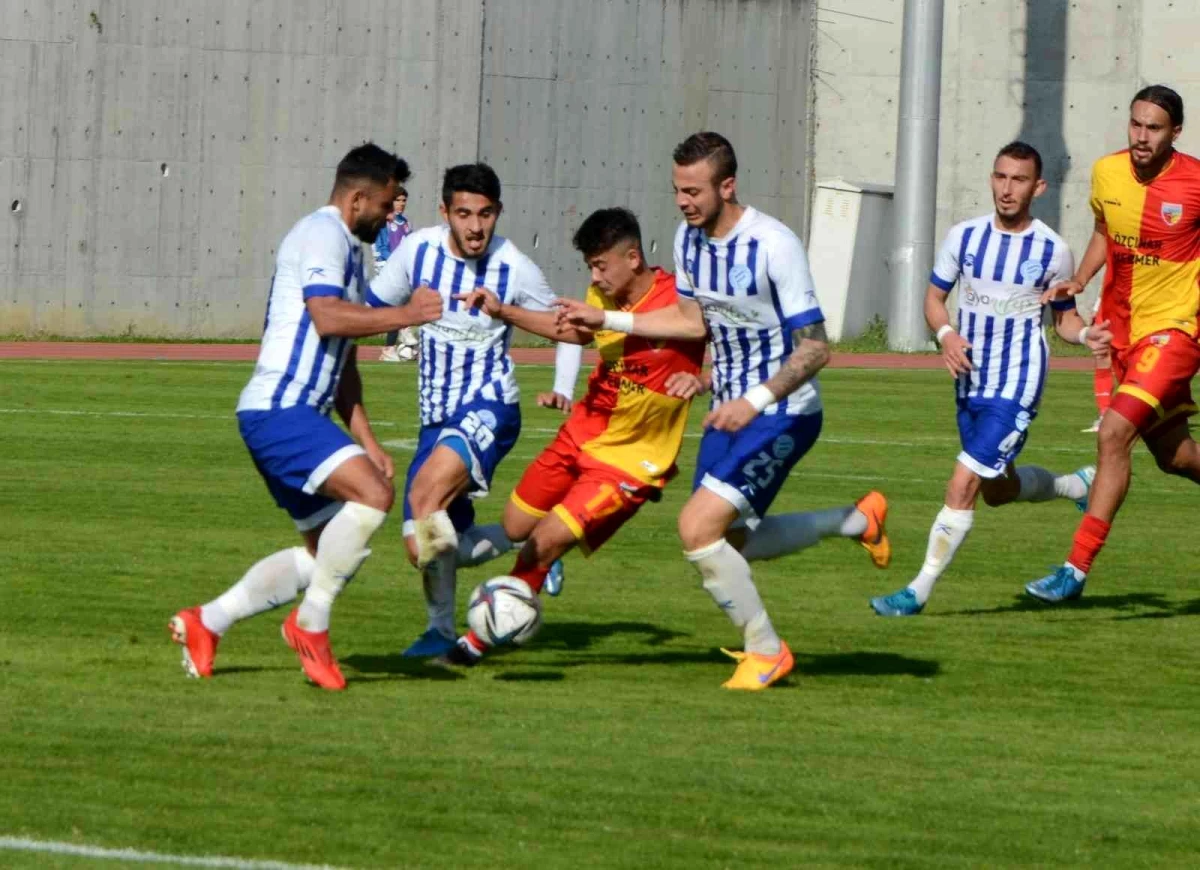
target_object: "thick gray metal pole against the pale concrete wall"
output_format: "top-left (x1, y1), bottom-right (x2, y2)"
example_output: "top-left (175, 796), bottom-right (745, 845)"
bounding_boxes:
top-left (888, 0), bottom-right (943, 350)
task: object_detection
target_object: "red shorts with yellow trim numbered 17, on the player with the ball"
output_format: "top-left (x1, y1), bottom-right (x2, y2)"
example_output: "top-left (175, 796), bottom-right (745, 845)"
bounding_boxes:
top-left (510, 432), bottom-right (660, 556)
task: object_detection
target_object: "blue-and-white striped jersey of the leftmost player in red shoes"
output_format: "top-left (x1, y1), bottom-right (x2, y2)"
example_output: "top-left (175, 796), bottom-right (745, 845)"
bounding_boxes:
top-left (238, 205), bottom-right (366, 414)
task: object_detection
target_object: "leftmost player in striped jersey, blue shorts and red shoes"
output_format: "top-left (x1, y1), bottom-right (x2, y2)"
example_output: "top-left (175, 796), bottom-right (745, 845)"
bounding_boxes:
top-left (169, 144), bottom-right (442, 690)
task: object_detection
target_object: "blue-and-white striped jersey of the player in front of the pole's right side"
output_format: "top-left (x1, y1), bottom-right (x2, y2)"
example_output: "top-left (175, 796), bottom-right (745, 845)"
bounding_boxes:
top-left (929, 214), bottom-right (1075, 409)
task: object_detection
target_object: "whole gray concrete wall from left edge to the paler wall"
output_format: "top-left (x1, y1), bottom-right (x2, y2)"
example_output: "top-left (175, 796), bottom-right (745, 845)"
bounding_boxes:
top-left (0, 0), bottom-right (810, 337)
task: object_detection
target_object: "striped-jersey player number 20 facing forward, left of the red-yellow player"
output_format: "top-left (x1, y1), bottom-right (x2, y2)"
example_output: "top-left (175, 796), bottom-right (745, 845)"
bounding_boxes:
top-left (368, 163), bottom-right (580, 656)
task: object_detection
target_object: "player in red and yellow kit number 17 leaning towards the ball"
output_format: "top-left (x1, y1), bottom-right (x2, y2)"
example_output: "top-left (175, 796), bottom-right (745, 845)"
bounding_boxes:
top-left (448, 209), bottom-right (704, 665)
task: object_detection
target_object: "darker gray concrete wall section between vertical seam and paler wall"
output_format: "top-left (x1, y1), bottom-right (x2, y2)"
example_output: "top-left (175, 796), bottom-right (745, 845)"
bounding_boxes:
top-left (480, 0), bottom-right (810, 293)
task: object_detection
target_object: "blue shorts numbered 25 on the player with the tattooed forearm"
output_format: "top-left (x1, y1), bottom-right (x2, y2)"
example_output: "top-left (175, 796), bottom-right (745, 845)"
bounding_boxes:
top-left (691, 412), bottom-right (822, 528)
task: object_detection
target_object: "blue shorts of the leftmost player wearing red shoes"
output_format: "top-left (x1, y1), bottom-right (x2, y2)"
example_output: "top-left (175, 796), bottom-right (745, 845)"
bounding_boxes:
top-left (238, 404), bottom-right (366, 532)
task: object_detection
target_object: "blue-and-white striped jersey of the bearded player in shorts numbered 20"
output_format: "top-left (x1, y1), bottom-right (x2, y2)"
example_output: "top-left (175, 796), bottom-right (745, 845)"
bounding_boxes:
top-left (367, 226), bottom-right (554, 426)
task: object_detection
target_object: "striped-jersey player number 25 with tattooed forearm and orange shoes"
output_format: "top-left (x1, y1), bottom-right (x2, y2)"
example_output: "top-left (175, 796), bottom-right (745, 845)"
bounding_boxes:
top-left (558, 133), bottom-right (890, 690)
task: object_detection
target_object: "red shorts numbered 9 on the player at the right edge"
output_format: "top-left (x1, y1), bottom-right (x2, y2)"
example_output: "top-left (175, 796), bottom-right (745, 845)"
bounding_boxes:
top-left (1111, 329), bottom-right (1200, 433)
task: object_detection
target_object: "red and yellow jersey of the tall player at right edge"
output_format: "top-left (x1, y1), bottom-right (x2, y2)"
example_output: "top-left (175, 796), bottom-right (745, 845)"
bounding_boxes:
top-left (1092, 150), bottom-right (1200, 349)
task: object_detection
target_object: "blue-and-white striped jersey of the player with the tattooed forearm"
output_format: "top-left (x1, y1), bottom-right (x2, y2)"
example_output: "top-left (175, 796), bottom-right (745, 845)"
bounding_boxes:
top-left (674, 206), bottom-right (824, 415)
